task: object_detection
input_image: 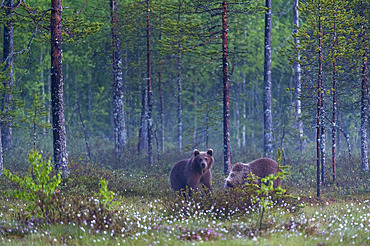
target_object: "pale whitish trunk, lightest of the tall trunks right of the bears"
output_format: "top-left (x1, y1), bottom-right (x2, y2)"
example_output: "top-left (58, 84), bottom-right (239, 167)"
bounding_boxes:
top-left (293, 0), bottom-right (307, 152)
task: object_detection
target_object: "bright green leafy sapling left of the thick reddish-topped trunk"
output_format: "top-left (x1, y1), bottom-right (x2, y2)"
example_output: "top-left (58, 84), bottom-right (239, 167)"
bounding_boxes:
top-left (4, 150), bottom-right (62, 221)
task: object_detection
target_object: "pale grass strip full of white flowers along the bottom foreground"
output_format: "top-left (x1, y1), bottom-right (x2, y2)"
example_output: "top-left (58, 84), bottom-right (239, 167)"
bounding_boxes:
top-left (0, 198), bottom-right (370, 245)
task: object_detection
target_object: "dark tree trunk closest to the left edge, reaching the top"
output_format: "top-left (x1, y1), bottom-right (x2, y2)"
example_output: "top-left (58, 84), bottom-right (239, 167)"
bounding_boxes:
top-left (2, 0), bottom-right (14, 149)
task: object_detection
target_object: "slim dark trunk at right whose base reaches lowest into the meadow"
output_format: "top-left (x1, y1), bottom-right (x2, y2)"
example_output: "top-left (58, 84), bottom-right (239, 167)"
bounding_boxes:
top-left (316, 0), bottom-right (322, 199)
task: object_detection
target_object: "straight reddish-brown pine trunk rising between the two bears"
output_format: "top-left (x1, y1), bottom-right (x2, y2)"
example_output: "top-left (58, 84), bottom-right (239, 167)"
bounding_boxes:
top-left (222, 0), bottom-right (231, 174)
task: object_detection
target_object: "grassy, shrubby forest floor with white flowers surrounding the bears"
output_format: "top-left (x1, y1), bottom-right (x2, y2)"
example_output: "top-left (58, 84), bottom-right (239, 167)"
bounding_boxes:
top-left (0, 147), bottom-right (370, 246)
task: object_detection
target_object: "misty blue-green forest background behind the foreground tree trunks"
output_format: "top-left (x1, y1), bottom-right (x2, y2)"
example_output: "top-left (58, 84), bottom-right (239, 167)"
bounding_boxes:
top-left (0, 0), bottom-right (370, 184)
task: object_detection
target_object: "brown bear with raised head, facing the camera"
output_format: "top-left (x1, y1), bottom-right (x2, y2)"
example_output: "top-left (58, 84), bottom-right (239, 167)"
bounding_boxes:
top-left (170, 149), bottom-right (213, 194)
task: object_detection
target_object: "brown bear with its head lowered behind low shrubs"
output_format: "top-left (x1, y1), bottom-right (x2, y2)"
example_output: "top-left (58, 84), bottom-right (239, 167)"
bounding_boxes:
top-left (224, 158), bottom-right (282, 189)
